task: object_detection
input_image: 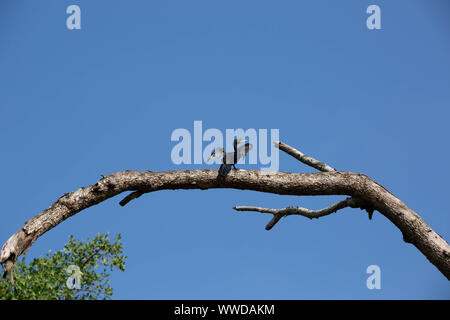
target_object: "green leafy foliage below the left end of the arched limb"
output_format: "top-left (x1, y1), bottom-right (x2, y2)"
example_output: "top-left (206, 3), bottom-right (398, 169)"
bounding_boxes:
top-left (0, 233), bottom-right (126, 300)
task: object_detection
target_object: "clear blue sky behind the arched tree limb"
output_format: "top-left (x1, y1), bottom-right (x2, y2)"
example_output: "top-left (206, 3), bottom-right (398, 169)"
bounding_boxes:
top-left (0, 0), bottom-right (450, 299)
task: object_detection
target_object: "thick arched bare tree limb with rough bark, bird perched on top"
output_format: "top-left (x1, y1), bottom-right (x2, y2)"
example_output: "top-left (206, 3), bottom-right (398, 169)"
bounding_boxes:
top-left (0, 170), bottom-right (450, 279)
